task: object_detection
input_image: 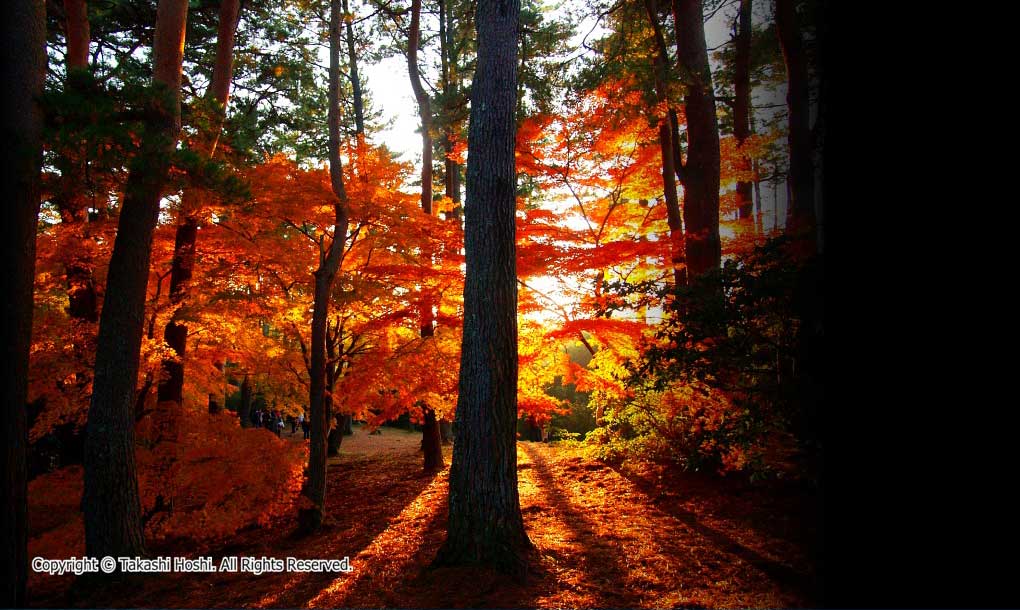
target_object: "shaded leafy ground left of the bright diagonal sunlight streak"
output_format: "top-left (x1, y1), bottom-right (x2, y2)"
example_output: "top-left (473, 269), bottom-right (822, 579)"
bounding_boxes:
top-left (40, 450), bottom-right (437, 608)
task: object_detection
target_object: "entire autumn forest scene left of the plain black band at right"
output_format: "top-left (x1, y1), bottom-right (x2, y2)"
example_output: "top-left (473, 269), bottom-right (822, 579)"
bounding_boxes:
top-left (0, 0), bottom-right (829, 608)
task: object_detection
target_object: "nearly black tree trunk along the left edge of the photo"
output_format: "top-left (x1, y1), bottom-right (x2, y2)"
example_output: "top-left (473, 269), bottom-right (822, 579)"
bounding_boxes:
top-left (0, 0), bottom-right (46, 608)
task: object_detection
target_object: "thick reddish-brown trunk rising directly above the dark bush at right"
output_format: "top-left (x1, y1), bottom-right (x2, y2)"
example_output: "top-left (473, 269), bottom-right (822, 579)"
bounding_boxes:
top-left (672, 0), bottom-right (722, 277)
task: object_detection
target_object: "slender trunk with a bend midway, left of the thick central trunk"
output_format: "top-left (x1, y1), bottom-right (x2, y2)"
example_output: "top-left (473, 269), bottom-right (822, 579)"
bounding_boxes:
top-left (298, 0), bottom-right (349, 532)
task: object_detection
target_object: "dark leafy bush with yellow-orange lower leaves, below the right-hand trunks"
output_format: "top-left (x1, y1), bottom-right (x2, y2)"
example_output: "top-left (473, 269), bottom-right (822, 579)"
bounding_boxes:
top-left (588, 238), bottom-right (817, 477)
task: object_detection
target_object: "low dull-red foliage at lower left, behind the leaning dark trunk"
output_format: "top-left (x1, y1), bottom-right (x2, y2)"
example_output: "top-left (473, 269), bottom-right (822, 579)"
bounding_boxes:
top-left (29, 413), bottom-right (307, 557)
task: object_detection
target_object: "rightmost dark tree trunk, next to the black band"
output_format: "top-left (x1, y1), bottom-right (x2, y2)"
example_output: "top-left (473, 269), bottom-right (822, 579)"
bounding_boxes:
top-left (775, 0), bottom-right (815, 243)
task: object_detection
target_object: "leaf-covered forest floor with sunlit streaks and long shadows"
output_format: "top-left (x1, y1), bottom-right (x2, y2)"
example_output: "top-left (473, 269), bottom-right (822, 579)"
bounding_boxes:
top-left (29, 427), bottom-right (822, 608)
